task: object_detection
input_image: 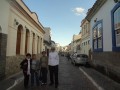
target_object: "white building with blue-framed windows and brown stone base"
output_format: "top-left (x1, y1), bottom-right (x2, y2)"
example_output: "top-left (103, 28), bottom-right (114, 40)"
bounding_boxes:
top-left (86, 0), bottom-right (120, 81)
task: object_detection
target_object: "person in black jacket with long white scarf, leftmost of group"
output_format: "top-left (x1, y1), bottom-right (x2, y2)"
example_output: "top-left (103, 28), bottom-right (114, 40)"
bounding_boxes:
top-left (20, 53), bottom-right (32, 88)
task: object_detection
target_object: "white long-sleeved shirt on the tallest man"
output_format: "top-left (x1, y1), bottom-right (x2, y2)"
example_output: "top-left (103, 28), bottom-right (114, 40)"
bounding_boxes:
top-left (48, 52), bottom-right (59, 66)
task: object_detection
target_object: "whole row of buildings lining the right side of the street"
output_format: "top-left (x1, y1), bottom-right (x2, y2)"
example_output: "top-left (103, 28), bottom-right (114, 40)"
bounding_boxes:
top-left (67, 0), bottom-right (120, 82)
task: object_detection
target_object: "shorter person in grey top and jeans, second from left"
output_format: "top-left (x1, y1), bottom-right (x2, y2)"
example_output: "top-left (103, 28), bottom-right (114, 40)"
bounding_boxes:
top-left (31, 54), bottom-right (40, 86)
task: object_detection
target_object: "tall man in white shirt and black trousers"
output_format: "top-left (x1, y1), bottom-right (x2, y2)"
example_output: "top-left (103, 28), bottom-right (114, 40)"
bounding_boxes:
top-left (48, 47), bottom-right (59, 88)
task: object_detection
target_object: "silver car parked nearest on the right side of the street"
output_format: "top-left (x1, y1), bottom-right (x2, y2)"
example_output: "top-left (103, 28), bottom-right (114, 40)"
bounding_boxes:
top-left (71, 54), bottom-right (88, 65)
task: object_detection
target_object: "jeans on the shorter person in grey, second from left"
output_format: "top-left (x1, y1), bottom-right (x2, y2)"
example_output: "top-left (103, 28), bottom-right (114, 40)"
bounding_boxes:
top-left (31, 70), bottom-right (39, 86)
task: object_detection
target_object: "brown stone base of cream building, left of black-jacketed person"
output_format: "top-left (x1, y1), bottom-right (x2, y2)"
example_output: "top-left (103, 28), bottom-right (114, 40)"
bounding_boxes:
top-left (5, 55), bottom-right (25, 77)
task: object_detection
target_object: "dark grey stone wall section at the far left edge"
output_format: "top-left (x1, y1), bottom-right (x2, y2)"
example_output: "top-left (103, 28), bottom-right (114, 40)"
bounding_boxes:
top-left (0, 33), bottom-right (7, 80)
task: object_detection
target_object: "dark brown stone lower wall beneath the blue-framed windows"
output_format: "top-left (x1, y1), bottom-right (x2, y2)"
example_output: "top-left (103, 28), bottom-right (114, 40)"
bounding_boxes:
top-left (91, 52), bottom-right (120, 83)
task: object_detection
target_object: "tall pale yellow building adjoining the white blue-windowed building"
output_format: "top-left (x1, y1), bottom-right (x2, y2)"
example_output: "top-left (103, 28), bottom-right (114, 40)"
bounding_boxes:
top-left (81, 19), bottom-right (90, 55)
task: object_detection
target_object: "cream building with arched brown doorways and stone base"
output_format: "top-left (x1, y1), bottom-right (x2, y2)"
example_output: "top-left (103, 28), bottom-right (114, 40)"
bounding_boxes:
top-left (0, 0), bottom-right (45, 78)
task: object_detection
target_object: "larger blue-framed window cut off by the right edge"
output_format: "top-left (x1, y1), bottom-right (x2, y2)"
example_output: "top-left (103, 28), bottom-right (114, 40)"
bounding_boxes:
top-left (111, 2), bottom-right (120, 51)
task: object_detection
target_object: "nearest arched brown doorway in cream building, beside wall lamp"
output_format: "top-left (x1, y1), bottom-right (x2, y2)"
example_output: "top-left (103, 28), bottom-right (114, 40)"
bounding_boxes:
top-left (16, 25), bottom-right (23, 54)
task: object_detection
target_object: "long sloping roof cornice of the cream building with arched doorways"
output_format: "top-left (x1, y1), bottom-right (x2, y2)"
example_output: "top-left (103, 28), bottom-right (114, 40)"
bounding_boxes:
top-left (10, 0), bottom-right (45, 34)
